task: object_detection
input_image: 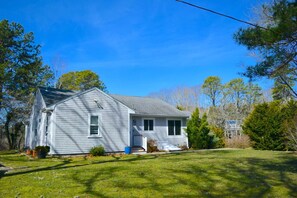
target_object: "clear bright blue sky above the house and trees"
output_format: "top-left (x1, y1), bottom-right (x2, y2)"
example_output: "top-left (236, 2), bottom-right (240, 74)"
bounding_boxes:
top-left (0, 0), bottom-right (270, 96)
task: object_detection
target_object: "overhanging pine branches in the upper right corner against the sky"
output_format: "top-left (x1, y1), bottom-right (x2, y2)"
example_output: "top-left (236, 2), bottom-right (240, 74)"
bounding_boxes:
top-left (234, 0), bottom-right (297, 97)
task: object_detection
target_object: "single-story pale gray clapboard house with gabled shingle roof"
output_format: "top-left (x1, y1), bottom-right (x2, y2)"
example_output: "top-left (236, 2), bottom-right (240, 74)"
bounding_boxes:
top-left (25, 87), bottom-right (189, 155)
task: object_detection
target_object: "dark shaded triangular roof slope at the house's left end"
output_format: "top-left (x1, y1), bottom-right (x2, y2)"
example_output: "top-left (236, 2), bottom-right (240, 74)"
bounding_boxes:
top-left (39, 87), bottom-right (78, 106)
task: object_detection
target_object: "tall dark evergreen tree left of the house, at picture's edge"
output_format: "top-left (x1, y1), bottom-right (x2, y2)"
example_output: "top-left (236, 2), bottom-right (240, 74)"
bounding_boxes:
top-left (0, 20), bottom-right (52, 149)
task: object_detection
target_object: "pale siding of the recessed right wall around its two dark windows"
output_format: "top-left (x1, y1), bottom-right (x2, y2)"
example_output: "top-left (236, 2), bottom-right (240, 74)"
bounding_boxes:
top-left (131, 116), bottom-right (188, 146)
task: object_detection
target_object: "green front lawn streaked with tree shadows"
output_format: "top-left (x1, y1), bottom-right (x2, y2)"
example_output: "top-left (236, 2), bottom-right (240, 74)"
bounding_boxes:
top-left (0, 149), bottom-right (297, 198)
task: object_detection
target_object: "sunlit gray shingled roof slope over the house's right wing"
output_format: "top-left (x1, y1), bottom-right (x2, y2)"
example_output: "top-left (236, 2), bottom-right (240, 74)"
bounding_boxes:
top-left (111, 94), bottom-right (190, 117)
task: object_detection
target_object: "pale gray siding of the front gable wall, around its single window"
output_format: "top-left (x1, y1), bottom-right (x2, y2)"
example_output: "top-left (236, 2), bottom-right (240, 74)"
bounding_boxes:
top-left (51, 89), bottom-right (130, 154)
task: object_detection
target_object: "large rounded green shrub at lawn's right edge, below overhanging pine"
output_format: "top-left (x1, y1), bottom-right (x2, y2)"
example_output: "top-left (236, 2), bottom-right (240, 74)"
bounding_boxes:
top-left (243, 101), bottom-right (297, 150)
